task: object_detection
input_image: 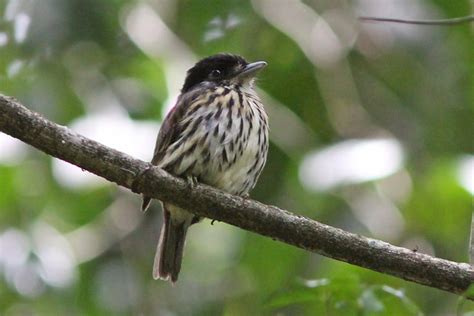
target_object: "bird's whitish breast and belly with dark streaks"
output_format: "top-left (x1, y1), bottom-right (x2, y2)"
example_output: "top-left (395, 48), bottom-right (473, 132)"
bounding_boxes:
top-left (160, 87), bottom-right (268, 195)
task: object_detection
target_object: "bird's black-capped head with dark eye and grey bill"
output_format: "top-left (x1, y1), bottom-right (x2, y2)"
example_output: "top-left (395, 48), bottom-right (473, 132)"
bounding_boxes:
top-left (181, 54), bottom-right (267, 93)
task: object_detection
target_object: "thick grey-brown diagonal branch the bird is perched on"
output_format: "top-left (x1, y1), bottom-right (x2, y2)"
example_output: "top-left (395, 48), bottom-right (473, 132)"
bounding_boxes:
top-left (0, 95), bottom-right (474, 299)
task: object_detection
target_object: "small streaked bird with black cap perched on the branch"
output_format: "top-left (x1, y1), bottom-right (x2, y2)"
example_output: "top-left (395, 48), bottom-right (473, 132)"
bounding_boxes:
top-left (142, 53), bottom-right (269, 284)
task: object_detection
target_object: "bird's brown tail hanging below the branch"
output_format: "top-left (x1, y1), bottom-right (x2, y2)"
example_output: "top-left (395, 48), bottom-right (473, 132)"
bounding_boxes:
top-left (153, 205), bottom-right (192, 283)
